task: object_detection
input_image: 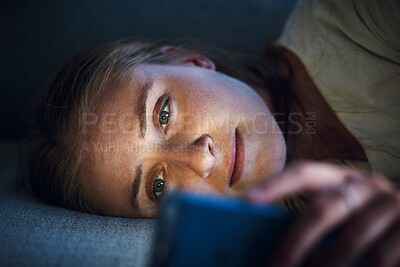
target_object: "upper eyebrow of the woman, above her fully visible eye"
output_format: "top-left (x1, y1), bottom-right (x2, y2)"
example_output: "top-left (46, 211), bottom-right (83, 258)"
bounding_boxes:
top-left (136, 75), bottom-right (154, 139)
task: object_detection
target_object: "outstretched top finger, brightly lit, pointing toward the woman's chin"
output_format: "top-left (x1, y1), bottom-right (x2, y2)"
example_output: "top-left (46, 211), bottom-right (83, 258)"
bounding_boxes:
top-left (248, 162), bottom-right (365, 203)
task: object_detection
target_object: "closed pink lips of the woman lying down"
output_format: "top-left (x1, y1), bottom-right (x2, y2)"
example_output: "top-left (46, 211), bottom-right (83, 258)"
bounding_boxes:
top-left (229, 129), bottom-right (244, 187)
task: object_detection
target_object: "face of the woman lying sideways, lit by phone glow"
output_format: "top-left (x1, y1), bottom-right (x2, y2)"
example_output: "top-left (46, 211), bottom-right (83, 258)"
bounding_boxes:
top-left (81, 64), bottom-right (286, 217)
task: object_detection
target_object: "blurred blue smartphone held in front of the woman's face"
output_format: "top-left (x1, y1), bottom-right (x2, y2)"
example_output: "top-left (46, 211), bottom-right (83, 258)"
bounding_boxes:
top-left (151, 192), bottom-right (293, 267)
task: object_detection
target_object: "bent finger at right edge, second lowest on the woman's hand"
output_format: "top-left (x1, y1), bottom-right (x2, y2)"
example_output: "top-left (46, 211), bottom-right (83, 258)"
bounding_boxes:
top-left (326, 194), bottom-right (400, 267)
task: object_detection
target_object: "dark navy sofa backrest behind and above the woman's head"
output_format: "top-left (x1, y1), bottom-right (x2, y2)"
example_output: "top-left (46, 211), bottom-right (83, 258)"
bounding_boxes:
top-left (0, 0), bottom-right (296, 140)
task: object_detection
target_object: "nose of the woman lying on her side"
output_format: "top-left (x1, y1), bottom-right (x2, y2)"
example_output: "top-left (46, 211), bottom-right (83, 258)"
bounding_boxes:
top-left (167, 134), bottom-right (216, 178)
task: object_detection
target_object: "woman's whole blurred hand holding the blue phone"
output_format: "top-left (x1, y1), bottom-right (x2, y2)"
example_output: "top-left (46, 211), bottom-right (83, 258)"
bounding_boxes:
top-left (249, 162), bottom-right (400, 267)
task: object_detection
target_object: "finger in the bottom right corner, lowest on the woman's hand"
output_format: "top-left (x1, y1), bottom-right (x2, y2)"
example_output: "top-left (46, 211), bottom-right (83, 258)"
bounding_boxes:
top-left (362, 221), bottom-right (400, 267)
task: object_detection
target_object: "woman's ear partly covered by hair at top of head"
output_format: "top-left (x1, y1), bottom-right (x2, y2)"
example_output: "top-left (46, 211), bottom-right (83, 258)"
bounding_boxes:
top-left (160, 45), bottom-right (216, 70)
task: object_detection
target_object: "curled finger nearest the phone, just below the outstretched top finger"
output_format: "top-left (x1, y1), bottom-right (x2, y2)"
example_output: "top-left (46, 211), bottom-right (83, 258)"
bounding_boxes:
top-left (272, 182), bottom-right (377, 266)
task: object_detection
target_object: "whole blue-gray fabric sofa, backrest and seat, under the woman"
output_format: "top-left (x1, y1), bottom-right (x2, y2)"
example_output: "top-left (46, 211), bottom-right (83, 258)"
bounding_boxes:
top-left (0, 0), bottom-right (296, 266)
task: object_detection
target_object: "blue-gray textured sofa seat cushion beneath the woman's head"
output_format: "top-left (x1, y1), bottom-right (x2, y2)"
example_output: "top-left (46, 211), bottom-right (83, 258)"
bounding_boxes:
top-left (0, 143), bottom-right (156, 266)
